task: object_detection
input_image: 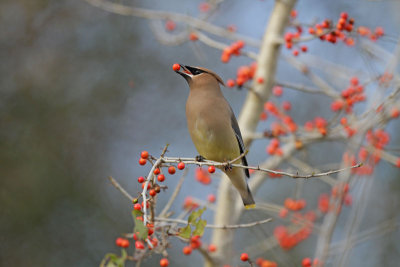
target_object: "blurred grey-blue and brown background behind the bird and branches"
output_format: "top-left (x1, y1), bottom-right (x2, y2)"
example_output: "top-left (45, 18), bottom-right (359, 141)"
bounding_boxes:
top-left (0, 0), bottom-right (400, 266)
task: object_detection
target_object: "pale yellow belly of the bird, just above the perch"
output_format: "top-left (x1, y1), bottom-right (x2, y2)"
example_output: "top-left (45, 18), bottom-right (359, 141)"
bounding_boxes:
top-left (191, 119), bottom-right (240, 162)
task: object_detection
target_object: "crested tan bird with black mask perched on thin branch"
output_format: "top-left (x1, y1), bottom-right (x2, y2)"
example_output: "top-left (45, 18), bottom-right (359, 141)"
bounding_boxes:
top-left (175, 65), bottom-right (255, 208)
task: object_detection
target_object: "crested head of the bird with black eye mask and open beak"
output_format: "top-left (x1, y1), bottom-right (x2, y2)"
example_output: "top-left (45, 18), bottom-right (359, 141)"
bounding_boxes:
top-left (175, 64), bottom-right (225, 87)
